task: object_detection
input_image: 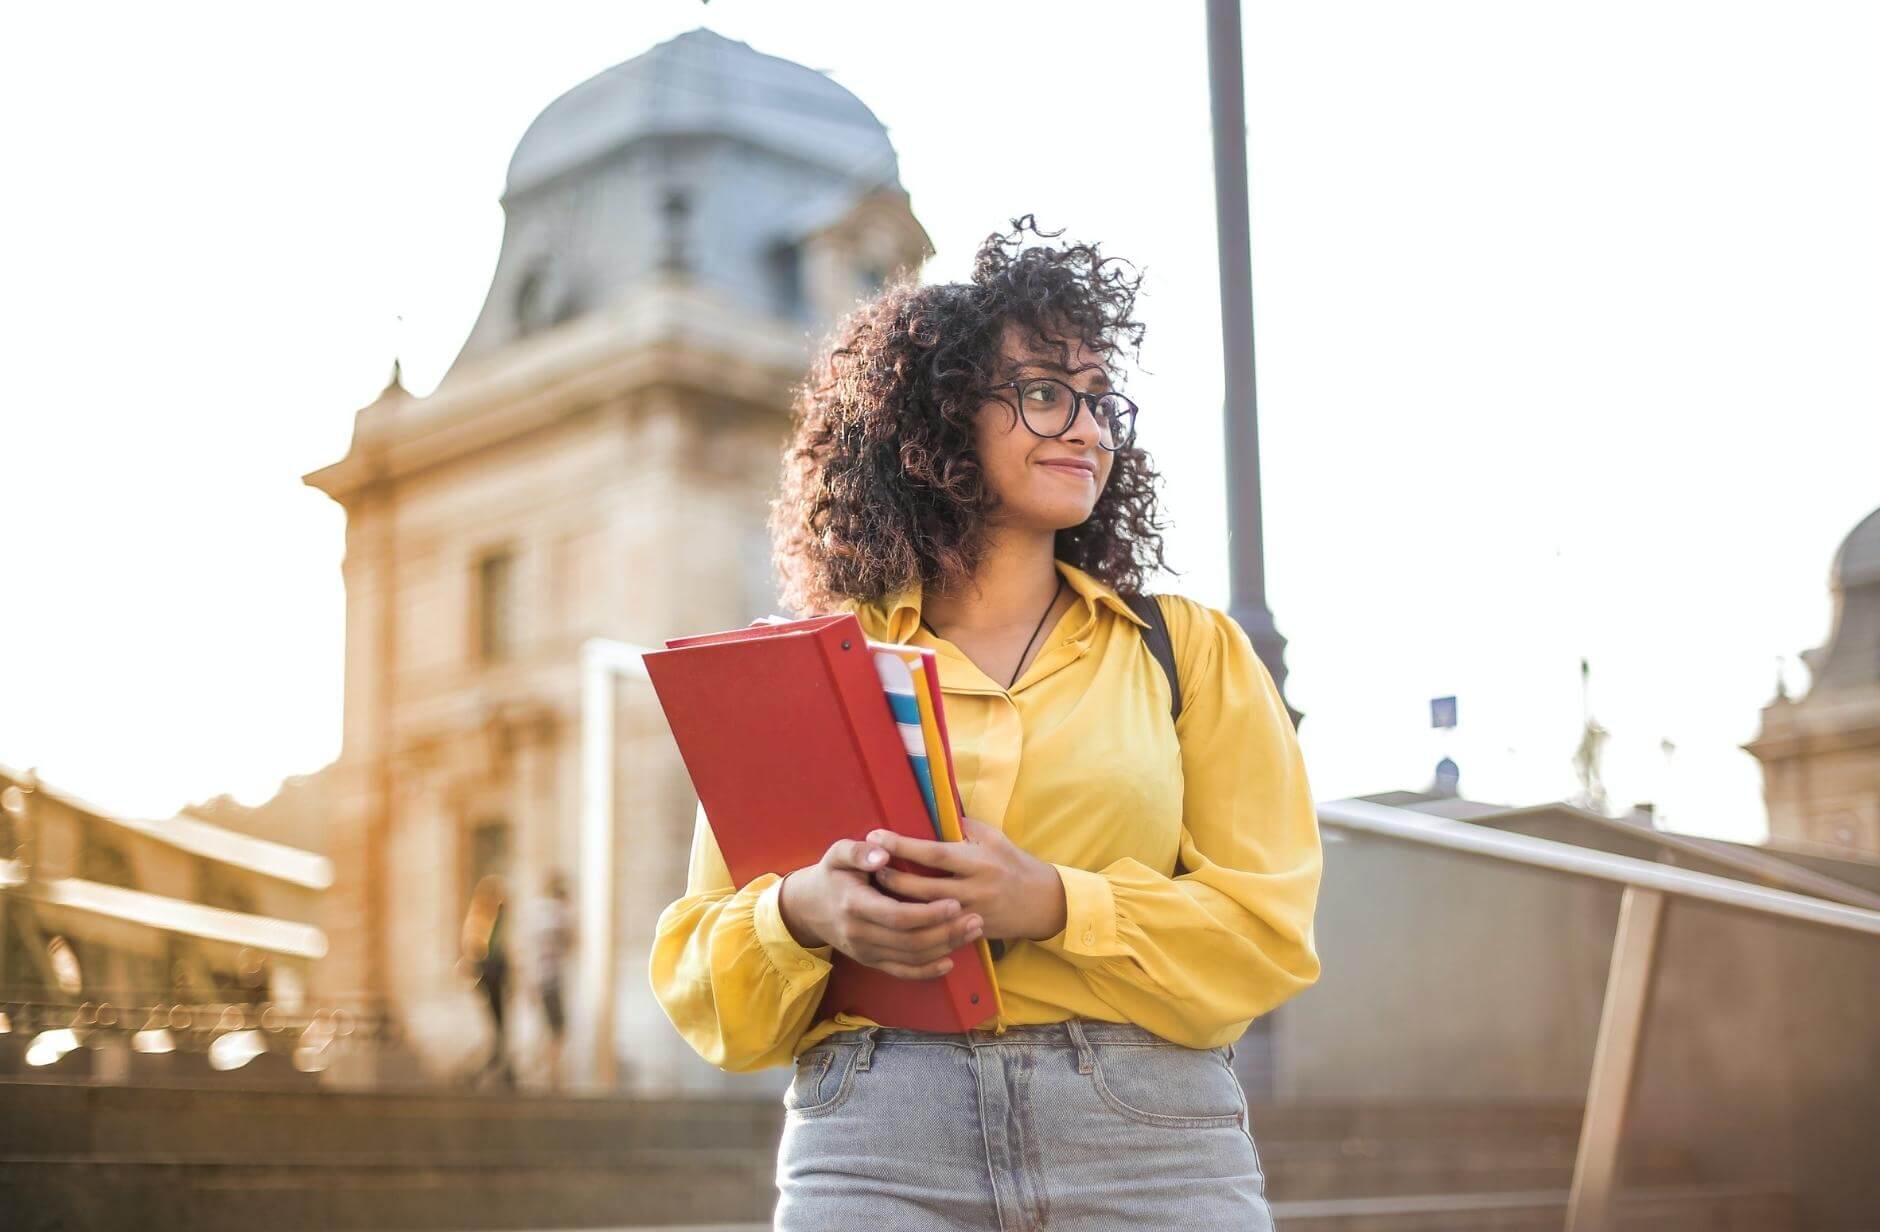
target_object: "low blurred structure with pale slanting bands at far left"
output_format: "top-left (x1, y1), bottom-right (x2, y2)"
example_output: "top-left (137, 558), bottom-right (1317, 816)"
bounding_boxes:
top-left (0, 766), bottom-right (333, 1078)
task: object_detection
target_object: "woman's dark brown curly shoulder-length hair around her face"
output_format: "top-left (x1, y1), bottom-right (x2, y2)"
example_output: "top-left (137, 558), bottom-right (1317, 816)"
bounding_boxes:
top-left (769, 214), bottom-right (1166, 613)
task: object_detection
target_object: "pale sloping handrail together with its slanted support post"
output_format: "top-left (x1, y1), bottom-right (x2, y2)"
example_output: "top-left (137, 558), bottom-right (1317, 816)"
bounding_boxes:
top-left (1318, 799), bottom-right (1880, 1232)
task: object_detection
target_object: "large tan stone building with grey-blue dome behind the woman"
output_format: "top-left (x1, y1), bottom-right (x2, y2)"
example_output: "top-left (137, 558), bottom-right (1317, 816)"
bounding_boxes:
top-left (306, 30), bottom-right (931, 1089)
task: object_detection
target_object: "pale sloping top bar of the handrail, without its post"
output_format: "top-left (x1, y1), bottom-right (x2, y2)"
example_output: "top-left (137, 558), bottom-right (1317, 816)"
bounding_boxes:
top-left (1318, 799), bottom-right (1880, 935)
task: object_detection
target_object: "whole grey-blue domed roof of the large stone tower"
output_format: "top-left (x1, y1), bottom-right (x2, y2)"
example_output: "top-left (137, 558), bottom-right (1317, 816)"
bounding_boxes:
top-left (444, 30), bottom-right (931, 382)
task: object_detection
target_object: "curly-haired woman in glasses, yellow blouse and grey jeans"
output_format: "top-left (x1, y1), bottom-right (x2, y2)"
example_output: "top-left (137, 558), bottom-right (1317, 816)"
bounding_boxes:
top-left (650, 216), bottom-right (1320, 1232)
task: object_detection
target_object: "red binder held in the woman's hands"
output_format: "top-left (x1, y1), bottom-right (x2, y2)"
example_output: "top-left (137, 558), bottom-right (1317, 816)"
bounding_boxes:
top-left (645, 613), bottom-right (998, 1031)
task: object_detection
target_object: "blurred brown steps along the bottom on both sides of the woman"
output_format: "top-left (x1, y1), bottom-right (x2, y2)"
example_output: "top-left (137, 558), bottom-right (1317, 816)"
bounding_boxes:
top-left (0, 1082), bottom-right (1797, 1232)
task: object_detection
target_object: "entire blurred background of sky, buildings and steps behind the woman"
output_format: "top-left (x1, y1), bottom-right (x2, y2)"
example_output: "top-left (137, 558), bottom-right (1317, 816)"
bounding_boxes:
top-left (0, 0), bottom-right (1880, 1228)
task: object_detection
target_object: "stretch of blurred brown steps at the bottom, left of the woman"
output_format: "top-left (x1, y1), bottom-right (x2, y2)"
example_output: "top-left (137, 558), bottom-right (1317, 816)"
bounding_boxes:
top-left (0, 1082), bottom-right (782, 1232)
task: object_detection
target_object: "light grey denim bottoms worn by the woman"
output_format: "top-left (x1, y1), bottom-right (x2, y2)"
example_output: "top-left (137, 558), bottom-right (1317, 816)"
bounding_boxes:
top-left (775, 1018), bottom-right (1273, 1232)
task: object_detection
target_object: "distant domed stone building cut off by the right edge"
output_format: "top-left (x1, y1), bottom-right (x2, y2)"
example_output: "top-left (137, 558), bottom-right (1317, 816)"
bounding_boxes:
top-left (1743, 510), bottom-right (1880, 860)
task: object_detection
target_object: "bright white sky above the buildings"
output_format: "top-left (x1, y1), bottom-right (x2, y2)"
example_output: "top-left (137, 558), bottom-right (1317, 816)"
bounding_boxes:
top-left (0, 0), bottom-right (1880, 837)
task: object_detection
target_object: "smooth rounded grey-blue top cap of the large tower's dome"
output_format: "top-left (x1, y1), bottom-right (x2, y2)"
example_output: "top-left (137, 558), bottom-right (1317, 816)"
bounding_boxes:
top-left (504, 28), bottom-right (899, 197)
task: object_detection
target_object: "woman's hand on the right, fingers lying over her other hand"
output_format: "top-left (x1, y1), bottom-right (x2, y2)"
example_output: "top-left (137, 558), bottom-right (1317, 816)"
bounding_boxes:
top-left (867, 816), bottom-right (1064, 940)
